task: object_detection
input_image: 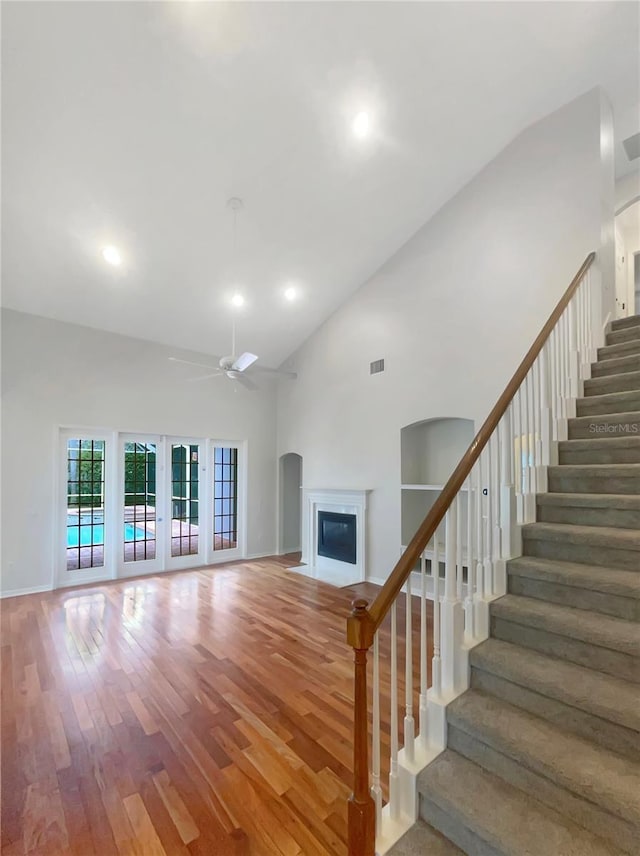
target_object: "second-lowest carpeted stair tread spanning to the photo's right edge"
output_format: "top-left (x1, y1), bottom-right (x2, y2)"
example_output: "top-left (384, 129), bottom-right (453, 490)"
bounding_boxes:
top-left (469, 639), bottom-right (640, 742)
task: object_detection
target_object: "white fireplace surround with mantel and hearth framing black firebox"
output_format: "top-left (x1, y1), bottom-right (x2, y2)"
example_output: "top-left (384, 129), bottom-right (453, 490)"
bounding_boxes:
top-left (299, 488), bottom-right (371, 586)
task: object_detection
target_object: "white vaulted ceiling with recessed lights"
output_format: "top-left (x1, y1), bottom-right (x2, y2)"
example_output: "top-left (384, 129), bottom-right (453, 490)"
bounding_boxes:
top-left (2, 2), bottom-right (640, 364)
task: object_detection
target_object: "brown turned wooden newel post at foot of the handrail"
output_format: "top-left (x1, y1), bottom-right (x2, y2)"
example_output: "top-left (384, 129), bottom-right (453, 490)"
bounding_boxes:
top-left (347, 600), bottom-right (376, 856)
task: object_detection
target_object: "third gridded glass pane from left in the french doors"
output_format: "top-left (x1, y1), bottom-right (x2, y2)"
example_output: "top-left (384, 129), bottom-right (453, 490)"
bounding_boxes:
top-left (171, 443), bottom-right (200, 556)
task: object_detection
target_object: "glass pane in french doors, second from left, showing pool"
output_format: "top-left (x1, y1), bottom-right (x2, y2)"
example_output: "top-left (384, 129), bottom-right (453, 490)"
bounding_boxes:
top-left (124, 443), bottom-right (157, 562)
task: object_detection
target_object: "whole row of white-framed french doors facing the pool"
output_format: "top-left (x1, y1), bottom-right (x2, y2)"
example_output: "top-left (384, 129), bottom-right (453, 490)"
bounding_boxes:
top-left (56, 430), bottom-right (246, 585)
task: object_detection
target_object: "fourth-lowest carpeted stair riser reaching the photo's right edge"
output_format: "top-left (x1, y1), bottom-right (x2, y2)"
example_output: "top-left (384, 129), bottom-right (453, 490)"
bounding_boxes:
top-left (507, 575), bottom-right (640, 620)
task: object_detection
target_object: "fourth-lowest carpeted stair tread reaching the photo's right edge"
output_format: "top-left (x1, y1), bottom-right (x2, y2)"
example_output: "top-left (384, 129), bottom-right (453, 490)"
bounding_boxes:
top-left (507, 556), bottom-right (640, 600)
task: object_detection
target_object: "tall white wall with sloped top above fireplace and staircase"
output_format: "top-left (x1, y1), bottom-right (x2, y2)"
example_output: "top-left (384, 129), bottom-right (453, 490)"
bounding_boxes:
top-left (278, 91), bottom-right (614, 578)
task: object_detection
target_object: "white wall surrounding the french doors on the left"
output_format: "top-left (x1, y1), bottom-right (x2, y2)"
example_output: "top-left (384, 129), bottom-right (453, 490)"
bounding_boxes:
top-left (1, 310), bottom-right (277, 593)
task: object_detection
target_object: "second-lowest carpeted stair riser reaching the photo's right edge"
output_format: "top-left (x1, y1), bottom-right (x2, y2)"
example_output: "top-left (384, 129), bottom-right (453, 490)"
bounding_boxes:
top-left (471, 668), bottom-right (640, 761)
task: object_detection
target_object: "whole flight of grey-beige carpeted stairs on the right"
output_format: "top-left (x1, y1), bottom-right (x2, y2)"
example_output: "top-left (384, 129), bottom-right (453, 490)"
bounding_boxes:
top-left (391, 316), bottom-right (640, 856)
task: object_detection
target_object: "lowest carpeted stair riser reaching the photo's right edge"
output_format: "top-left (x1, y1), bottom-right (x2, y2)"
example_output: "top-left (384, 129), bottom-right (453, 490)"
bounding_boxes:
top-left (447, 723), bottom-right (637, 853)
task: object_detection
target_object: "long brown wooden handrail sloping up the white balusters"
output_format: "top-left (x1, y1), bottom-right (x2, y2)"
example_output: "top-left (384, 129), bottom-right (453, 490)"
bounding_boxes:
top-left (368, 247), bottom-right (596, 633)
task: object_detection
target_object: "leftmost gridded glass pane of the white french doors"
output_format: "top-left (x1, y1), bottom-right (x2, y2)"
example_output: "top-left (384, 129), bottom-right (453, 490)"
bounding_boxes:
top-left (67, 438), bottom-right (105, 571)
